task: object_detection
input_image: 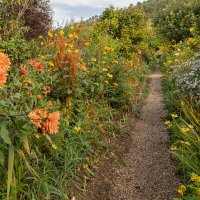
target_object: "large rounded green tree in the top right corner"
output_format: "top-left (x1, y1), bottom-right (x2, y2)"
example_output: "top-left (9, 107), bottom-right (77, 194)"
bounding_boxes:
top-left (154, 0), bottom-right (200, 43)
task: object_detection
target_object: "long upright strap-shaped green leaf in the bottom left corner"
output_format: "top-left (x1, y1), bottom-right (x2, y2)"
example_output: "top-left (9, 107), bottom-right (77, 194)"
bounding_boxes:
top-left (6, 144), bottom-right (15, 200)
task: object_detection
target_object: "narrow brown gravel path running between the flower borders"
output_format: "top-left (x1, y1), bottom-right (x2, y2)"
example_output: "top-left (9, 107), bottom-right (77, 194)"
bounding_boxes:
top-left (109, 66), bottom-right (178, 200)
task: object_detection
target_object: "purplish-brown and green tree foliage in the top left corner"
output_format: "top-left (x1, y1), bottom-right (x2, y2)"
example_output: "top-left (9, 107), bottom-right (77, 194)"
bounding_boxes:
top-left (0, 0), bottom-right (52, 39)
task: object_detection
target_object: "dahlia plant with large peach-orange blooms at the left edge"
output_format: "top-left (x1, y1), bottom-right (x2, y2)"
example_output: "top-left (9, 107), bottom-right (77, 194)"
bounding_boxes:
top-left (0, 53), bottom-right (60, 199)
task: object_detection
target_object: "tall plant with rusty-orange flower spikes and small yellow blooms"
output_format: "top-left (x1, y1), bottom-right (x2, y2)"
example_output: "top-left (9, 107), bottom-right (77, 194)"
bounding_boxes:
top-left (40, 26), bottom-right (80, 102)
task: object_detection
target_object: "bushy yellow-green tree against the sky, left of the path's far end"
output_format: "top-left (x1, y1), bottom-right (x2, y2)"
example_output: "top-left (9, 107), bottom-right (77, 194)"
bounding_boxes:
top-left (96, 6), bottom-right (147, 55)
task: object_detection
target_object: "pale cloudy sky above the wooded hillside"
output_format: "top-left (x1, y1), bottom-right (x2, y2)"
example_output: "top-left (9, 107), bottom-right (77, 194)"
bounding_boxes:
top-left (50, 0), bottom-right (143, 25)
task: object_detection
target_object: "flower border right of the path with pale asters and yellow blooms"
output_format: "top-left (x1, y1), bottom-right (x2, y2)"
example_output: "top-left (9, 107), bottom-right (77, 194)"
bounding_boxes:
top-left (160, 22), bottom-right (200, 200)
